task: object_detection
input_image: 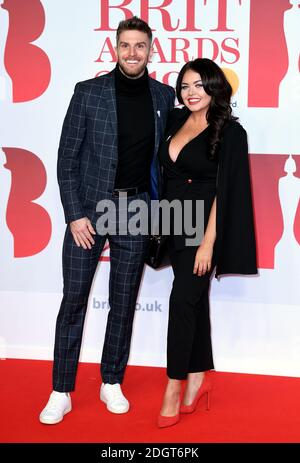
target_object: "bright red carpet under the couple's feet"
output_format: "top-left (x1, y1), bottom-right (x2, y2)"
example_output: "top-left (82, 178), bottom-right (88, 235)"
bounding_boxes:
top-left (0, 359), bottom-right (300, 443)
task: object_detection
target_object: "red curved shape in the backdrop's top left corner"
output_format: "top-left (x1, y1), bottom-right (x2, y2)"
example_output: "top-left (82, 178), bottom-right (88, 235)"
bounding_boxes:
top-left (2, 0), bottom-right (51, 103)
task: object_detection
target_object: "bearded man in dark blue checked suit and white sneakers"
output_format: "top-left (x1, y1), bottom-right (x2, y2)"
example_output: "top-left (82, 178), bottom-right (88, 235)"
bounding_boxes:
top-left (40, 17), bottom-right (175, 424)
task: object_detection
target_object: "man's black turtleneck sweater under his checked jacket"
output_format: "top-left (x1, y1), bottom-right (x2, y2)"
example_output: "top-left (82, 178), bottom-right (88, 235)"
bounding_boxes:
top-left (115, 65), bottom-right (155, 191)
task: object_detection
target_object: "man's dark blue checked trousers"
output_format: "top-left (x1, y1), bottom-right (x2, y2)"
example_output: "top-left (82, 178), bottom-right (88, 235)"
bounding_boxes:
top-left (53, 194), bottom-right (149, 392)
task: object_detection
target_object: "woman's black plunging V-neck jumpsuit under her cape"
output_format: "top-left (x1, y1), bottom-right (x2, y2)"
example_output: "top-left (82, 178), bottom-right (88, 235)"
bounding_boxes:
top-left (159, 114), bottom-right (218, 379)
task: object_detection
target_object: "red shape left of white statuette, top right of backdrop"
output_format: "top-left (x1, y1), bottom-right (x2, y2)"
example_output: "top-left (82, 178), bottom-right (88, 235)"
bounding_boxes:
top-left (248, 0), bottom-right (292, 108)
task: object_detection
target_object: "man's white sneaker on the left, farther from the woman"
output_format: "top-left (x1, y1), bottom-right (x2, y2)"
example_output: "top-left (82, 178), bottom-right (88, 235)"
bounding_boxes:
top-left (40, 391), bottom-right (72, 424)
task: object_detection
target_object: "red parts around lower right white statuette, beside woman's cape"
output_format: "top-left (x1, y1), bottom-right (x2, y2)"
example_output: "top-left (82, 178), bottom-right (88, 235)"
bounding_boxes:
top-left (250, 154), bottom-right (300, 269)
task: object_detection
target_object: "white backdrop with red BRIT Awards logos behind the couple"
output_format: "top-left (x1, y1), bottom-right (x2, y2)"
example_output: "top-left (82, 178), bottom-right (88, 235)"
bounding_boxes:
top-left (0, 0), bottom-right (300, 376)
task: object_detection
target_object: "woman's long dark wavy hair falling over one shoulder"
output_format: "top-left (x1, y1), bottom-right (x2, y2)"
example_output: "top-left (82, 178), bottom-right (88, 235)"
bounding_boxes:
top-left (176, 58), bottom-right (237, 159)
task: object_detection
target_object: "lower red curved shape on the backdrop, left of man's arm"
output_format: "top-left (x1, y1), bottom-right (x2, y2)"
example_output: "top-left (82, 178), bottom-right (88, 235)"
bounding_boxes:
top-left (2, 148), bottom-right (52, 257)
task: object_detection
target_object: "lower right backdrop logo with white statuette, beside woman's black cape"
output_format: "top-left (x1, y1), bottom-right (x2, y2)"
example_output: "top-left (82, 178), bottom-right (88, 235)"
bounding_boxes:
top-left (250, 154), bottom-right (300, 269)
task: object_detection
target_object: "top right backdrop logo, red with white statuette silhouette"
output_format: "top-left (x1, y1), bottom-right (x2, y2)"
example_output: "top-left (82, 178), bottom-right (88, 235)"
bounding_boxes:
top-left (248, 0), bottom-right (300, 108)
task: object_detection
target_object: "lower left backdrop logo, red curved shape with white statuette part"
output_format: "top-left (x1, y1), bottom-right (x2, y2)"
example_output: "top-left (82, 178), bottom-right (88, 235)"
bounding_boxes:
top-left (0, 147), bottom-right (52, 259)
